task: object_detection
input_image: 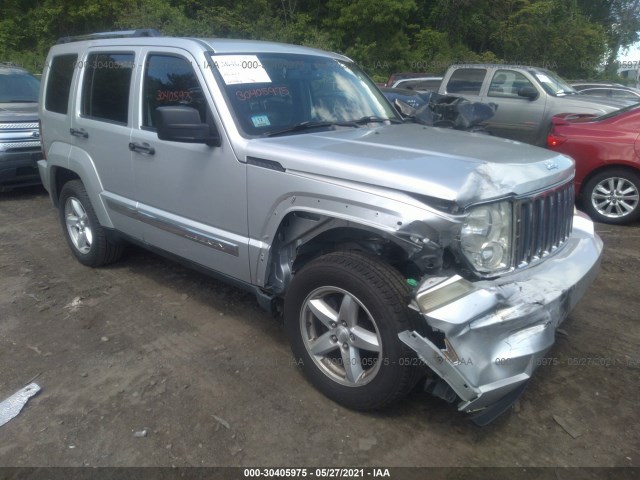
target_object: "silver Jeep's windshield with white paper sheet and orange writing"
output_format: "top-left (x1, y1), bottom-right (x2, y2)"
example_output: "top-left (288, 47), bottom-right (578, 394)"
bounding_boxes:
top-left (211, 53), bottom-right (399, 136)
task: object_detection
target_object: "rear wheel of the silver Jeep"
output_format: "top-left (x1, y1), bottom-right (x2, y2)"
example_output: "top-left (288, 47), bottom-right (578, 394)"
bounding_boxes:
top-left (58, 180), bottom-right (123, 267)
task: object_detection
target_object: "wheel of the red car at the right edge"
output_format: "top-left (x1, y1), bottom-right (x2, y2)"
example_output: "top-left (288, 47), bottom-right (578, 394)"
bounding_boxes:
top-left (583, 168), bottom-right (640, 225)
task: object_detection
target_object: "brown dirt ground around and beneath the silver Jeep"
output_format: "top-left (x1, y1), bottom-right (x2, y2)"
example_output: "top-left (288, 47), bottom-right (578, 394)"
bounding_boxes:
top-left (0, 188), bottom-right (640, 468)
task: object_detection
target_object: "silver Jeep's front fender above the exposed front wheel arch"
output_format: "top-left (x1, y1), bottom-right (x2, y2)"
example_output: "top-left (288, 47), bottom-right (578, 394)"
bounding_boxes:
top-left (247, 165), bottom-right (458, 287)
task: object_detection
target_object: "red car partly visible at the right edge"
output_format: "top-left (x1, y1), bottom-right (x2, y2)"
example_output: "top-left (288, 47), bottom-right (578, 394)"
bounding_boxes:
top-left (547, 104), bottom-right (640, 224)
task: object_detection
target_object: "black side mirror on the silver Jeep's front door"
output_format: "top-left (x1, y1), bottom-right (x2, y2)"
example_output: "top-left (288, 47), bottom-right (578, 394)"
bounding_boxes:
top-left (155, 105), bottom-right (221, 147)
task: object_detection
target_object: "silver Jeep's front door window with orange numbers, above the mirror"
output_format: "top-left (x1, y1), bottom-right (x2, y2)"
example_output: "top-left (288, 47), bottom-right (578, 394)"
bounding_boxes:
top-left (142, 55), bottom-right (208, 128)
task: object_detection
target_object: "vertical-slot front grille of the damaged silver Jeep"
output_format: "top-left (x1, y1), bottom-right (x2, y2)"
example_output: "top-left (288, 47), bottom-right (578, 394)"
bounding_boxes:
top-left (514, 182), bottom-right (574, 268)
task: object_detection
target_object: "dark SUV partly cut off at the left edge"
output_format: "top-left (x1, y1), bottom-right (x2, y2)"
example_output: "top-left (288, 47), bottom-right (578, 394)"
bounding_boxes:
top-left (0, 62), bottom-right (42, 191)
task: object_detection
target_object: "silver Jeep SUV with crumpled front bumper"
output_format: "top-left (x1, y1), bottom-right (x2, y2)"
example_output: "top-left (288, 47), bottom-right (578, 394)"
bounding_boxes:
top-left (38, 32), bottom-right (602, 424)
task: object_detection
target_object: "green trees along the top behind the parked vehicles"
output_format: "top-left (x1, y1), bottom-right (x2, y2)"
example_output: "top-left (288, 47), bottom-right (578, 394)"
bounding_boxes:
top-left (0, 0), bottom-right (640, 80)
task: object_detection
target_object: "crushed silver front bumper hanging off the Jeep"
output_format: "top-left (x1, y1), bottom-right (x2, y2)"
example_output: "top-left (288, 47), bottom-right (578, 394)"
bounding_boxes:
top-left (399, 212), bottom-right (602, 423)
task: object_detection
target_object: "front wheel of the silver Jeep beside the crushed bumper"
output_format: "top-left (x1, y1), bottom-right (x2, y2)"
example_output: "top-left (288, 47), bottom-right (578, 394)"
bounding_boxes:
top-left (284, 252), bottom-right (421, 410)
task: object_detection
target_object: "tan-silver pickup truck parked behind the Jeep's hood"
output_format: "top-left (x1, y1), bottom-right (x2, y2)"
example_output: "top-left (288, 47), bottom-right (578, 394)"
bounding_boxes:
top-left (438, 64), bottom-right (632, 146)
